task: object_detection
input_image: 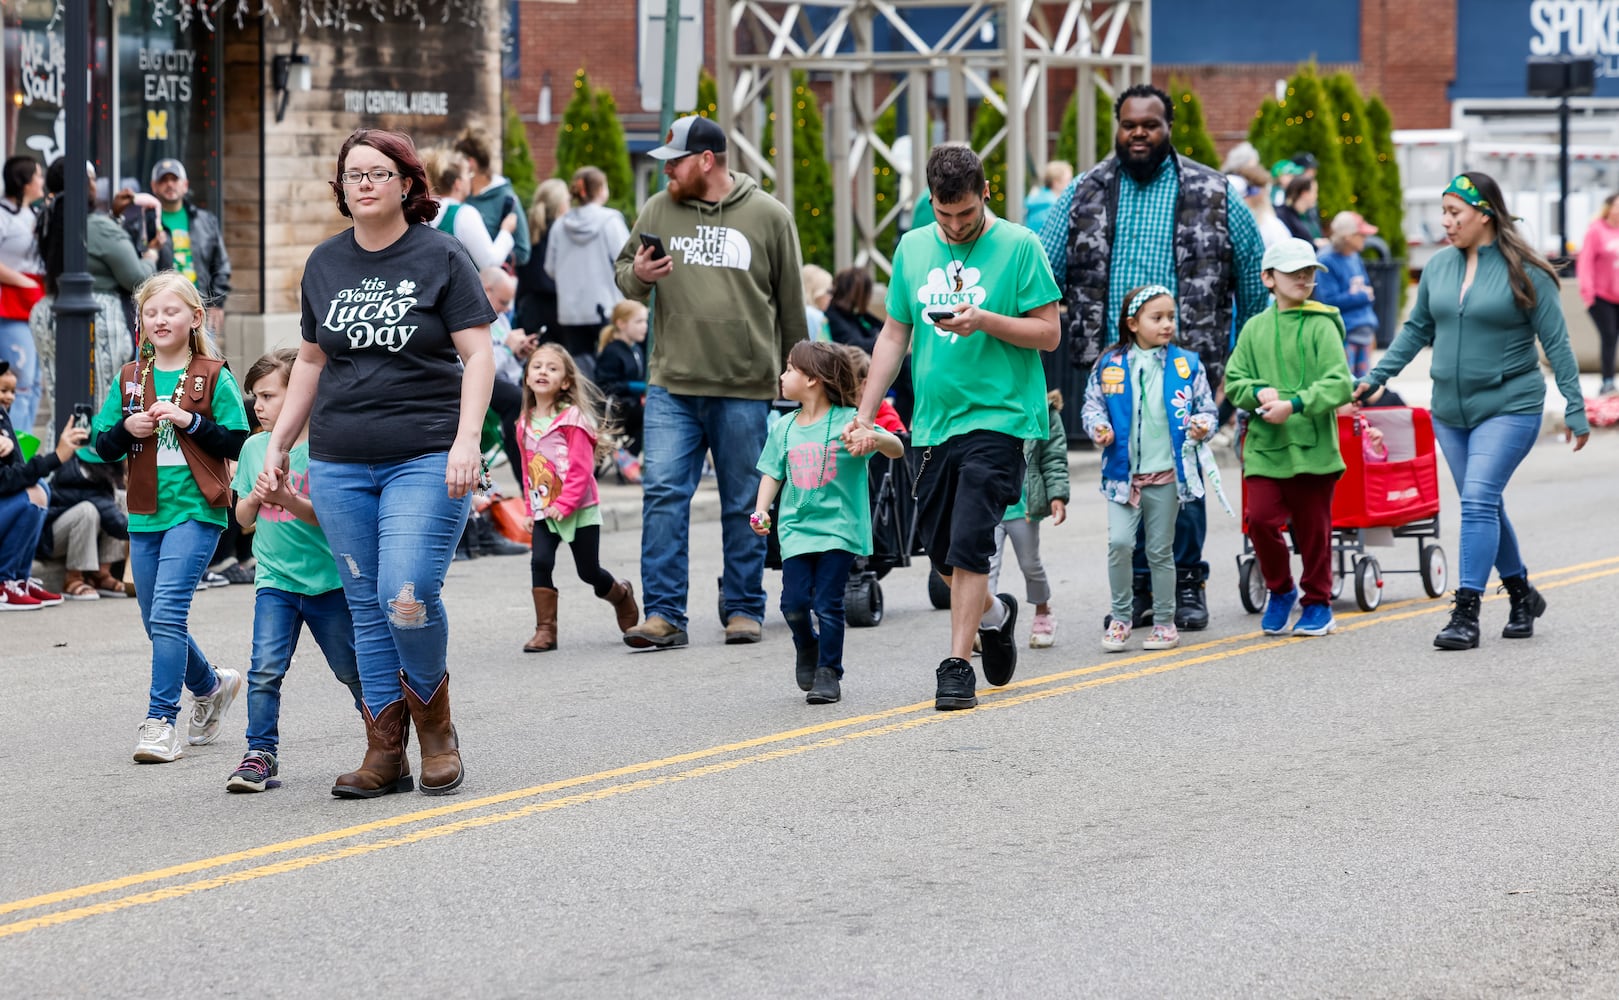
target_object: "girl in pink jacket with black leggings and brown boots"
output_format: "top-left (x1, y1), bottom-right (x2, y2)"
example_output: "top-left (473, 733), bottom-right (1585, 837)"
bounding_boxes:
top-left (518, 343), bottom-right (641, 652)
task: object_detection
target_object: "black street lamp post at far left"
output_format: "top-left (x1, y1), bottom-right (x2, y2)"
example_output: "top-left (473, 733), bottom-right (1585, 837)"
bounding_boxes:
top-left (52, 0), bottom-right (96, 435)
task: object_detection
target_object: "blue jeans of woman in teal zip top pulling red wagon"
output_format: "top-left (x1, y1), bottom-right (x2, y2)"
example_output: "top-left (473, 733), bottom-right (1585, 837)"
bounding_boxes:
top-left (1433, 413), bottom-right (1541, 591)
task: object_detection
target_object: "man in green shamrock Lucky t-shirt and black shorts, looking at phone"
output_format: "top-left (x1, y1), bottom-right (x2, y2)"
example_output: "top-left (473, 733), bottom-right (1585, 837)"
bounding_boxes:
top-left (847, 142), bottom-right (1062, 712)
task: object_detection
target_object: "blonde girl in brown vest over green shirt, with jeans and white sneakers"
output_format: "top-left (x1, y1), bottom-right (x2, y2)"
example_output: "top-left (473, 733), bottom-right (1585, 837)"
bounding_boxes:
top-left (92, 270), bottom-right (248, 764)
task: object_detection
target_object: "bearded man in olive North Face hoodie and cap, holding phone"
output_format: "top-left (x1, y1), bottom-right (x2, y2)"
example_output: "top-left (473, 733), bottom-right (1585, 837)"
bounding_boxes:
top-left (615, 115), bottom-right (808, 649)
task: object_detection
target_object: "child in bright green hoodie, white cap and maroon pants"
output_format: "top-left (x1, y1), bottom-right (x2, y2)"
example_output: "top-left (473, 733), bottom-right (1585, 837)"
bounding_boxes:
top-left (1226, 239), bottom-right (1352, 636)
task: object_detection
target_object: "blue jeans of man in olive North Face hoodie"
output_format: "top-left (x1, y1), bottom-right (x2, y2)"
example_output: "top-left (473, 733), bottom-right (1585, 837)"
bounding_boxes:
top-left (641, 385), bottom-right (771, 629)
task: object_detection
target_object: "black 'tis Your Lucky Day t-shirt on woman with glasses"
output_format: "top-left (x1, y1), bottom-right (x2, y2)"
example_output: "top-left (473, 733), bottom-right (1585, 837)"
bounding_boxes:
top-left (303, 225), bottom-right (495, 463)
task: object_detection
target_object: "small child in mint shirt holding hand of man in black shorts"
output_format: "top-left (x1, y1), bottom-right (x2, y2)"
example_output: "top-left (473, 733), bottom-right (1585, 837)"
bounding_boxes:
top-left (748, 340), bottom-right (905, 706)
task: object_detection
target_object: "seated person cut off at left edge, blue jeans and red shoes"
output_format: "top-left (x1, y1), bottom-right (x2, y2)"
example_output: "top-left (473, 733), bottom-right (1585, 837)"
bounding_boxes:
top-left (0, 361), bottom-right (89, 612)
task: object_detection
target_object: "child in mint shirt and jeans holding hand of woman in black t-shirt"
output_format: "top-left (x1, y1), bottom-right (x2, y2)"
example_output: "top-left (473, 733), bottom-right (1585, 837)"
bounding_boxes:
top-left (225, 348), bottom-right (364, 791)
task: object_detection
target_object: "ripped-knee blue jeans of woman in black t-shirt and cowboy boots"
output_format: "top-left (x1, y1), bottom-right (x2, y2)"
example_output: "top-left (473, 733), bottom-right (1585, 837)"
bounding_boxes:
top-left (309, 451), bottom-right (473, 715)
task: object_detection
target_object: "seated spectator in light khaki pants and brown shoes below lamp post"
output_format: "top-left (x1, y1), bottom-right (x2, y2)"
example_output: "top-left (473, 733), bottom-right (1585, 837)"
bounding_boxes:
top-left (36, 451), bottom-right (130, 600)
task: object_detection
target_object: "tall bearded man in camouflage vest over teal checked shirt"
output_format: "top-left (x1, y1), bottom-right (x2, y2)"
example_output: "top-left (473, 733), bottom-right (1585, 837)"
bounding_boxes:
top-left (1039, 84), bottom-right (1268, 631)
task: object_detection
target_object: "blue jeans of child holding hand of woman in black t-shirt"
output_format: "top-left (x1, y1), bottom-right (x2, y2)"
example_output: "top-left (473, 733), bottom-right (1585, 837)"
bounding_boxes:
top-left (248, 587), bottom-right (363, 754)
